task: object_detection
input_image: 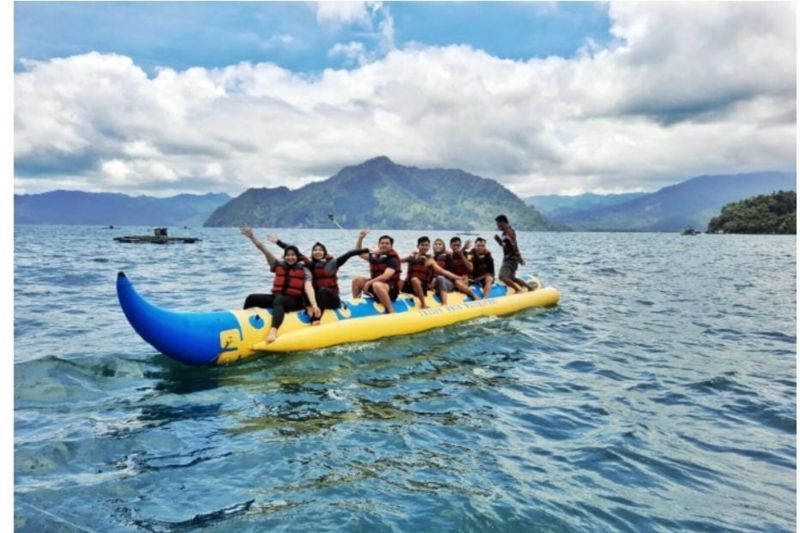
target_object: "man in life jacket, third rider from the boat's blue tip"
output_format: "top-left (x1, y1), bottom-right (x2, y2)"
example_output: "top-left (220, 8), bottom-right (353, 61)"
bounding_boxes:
top-left (353, 229), bottom-right (400, 313)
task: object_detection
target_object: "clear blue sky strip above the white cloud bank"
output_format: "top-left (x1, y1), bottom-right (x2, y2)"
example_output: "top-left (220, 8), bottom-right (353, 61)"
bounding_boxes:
top-left (14, 2), bottom-right (610, 74)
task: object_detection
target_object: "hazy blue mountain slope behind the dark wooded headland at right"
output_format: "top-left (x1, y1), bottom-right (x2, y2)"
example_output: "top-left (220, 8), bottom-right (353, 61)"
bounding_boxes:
top-left (553, 172), bottom-right (796, 231)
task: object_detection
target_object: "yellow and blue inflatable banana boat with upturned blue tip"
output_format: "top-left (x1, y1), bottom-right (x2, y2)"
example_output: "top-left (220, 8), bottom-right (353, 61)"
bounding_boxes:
top-left (117, 272), bottom-right (560, 365)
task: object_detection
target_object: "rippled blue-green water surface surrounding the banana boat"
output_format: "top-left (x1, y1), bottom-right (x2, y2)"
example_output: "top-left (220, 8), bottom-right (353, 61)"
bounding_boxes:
top-left (14, 226), bottom-right (797, 533)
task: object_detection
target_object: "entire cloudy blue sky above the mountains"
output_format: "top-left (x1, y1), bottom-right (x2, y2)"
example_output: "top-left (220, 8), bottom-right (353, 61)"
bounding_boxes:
top-left (13, 2), bottom-right (797, 197)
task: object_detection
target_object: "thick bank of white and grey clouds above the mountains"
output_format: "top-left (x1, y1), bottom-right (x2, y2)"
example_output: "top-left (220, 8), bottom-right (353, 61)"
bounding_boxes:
top-left (15, 3), bottom-right (796, 195)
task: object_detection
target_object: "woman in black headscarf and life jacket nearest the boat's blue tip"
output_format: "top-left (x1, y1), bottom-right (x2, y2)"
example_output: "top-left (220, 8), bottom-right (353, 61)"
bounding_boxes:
top-left (241, 227), bottom-right (320, 343)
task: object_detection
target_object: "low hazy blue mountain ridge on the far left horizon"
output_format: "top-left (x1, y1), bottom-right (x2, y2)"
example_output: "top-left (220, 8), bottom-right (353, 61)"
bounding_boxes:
top-left (14, 191), bottom-right (231, 226)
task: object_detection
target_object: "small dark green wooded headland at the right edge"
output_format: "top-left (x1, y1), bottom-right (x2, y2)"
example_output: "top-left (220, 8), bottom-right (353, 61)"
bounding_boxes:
top-left (708, 191), bottom-right (797, 234)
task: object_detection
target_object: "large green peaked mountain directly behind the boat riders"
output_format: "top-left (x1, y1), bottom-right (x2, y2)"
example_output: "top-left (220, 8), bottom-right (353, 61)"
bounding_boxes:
top-left (205, 157), bottom-right (560, 230)
